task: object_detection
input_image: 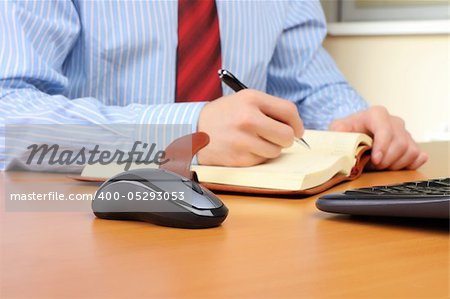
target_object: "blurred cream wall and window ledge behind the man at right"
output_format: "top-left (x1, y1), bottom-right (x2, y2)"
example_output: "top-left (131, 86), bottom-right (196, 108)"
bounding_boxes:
top-left (321, 0), bottom-right (450, 141)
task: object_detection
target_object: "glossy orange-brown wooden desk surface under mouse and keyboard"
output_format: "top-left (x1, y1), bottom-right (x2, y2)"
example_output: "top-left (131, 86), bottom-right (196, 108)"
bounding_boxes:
top-left (0, 143), bottom-right (450, 298)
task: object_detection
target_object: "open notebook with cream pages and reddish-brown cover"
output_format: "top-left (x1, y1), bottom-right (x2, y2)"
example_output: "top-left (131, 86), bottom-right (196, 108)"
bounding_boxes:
top-left (79, 130), bottom-right (372, 194)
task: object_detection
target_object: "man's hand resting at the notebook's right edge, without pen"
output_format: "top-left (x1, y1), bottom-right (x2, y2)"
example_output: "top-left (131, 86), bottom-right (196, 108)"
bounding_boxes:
top-left (330, 106), bottom-right (428, 170)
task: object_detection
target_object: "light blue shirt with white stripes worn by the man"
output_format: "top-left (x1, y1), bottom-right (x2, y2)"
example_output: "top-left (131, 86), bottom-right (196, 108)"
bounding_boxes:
top-left (0, 0), bottom-right (367, 172)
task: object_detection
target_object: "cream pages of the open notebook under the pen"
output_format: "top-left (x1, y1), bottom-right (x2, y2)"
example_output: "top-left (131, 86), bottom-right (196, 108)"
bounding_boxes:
top-left (192, 130), bottom-right (371, 190)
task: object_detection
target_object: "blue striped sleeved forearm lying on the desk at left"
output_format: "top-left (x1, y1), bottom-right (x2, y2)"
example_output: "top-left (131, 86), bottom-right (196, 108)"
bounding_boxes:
top-left (0, 88), bottom-right (204, 172)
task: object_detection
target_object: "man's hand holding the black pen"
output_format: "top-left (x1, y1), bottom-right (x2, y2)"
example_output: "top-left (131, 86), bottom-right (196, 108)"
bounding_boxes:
top-left (197, 89), bottom-right (303, 166)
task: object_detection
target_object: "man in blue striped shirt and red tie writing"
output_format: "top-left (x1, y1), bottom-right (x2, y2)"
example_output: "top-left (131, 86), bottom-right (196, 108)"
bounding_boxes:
top-left (0, 0), bottom-right (427, 169)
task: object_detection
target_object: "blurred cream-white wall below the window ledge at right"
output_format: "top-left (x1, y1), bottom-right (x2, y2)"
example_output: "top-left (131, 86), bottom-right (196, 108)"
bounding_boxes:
top-left (324, 35), bottom-right (450, 141)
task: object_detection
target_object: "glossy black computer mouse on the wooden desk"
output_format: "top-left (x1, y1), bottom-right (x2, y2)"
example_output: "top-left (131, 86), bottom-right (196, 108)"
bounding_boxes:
top-left (92, 169), bottom-right (228, 228)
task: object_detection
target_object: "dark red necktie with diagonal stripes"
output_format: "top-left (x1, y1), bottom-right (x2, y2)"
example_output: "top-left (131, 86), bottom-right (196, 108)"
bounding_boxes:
top-left (175, 0), bottom-right (222, 102)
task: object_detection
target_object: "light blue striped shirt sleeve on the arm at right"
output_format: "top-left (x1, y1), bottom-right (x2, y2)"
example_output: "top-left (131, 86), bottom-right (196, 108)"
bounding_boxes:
top-left (268, 1), bottom-right (368, 129)
